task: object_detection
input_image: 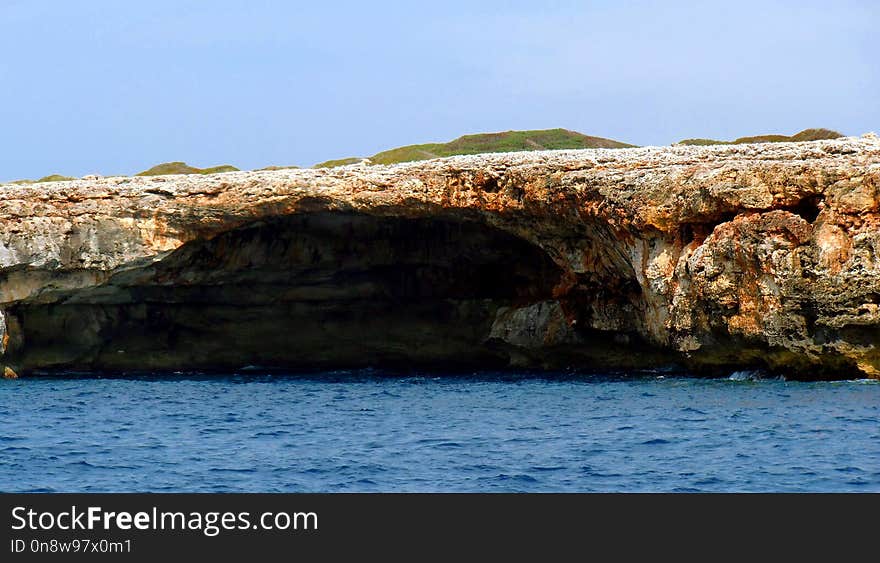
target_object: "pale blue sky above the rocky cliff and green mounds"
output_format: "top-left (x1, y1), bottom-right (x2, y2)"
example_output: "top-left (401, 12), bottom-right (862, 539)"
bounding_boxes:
top-left (0, 0), bottom-right (880, 180)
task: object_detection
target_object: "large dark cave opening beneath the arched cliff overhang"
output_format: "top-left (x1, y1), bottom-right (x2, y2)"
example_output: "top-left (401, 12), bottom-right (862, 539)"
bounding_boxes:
top-left (7, 212), bottom-right (576, 370)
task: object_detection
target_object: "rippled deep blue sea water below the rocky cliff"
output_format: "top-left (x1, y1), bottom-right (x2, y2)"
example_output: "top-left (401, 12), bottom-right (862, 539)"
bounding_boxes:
top-left (0, 371), bottom-right (880, 492)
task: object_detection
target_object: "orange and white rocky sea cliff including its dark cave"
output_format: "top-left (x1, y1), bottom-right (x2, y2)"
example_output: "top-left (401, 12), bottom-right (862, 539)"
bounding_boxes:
top-left (0, 135), bottom-right (880, 378)
